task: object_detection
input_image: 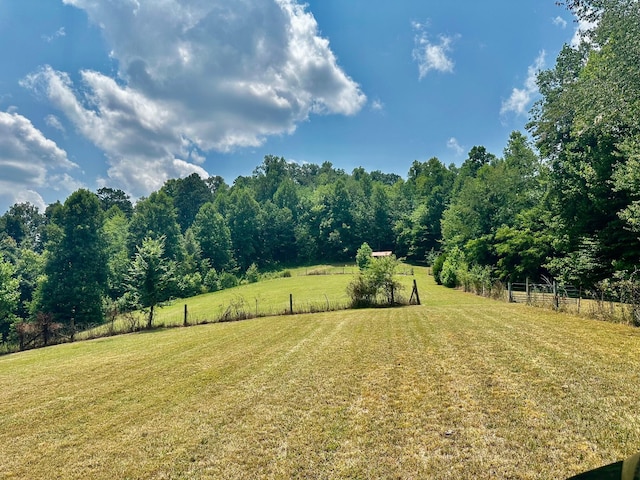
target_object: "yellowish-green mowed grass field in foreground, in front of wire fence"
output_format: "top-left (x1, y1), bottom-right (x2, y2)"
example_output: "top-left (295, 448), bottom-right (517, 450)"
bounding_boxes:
top-left (0, 276), bottom-right (640, 480)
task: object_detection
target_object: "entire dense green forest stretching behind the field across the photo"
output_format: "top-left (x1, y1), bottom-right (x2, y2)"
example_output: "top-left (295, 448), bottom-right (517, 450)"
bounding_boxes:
top-left (0, 0), bottom-right (640, 342)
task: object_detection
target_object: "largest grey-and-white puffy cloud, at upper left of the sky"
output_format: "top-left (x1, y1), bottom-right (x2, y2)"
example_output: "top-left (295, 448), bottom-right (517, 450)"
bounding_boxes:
top-left (24, 0), bottom-right (367, 195)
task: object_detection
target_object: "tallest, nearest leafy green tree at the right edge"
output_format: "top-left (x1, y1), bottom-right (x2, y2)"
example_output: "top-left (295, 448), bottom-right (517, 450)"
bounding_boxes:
top-left (529, 0), bottom-right (640, 284)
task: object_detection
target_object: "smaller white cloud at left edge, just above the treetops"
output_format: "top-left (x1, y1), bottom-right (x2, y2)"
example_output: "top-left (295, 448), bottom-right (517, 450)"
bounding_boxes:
top-left (0, 112), bottom-right (78, 208)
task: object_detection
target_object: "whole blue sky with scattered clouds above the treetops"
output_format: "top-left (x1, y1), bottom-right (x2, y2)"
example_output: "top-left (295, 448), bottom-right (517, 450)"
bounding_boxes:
top-left (0, 0), bottom-right (578, 212)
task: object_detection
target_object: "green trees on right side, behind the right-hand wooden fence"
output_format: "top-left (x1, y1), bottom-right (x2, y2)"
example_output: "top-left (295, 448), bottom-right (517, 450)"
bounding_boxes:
top-left (435, 0), bottom-right (640, 304)
